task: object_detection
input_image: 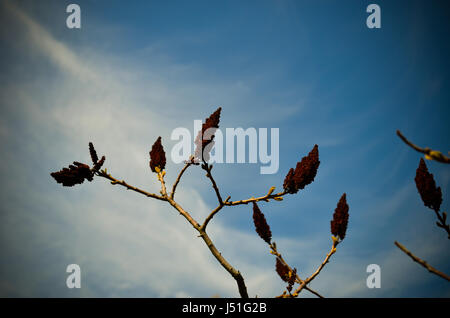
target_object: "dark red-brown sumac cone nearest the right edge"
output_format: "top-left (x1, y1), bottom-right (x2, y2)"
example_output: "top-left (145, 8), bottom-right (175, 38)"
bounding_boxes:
top-left (414, 158), bottom-right (442, 212)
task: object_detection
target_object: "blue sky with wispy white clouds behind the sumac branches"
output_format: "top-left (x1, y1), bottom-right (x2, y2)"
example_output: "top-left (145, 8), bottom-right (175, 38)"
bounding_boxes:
top-left (0, 1), bottom-right (450, 297)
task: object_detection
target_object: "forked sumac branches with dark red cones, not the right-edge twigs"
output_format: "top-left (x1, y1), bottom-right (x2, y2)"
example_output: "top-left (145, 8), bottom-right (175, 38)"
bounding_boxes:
top-left (51, 108), bottom-right (349, 298)
